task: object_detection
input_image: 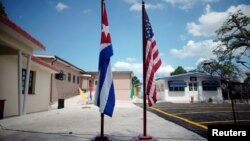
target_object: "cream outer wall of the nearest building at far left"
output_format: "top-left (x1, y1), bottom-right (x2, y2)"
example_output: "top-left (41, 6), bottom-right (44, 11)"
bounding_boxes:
top-left (0, 55), bottom-right (50, 117)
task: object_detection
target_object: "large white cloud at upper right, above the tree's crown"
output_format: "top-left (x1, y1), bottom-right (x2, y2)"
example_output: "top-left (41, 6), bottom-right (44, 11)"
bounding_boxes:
top-left (186, 4), bottom-right (250, 37)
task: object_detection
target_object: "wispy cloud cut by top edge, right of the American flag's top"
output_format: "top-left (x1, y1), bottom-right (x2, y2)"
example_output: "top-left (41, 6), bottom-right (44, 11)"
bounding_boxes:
top-left (163, 0), bottom-right (218, 11)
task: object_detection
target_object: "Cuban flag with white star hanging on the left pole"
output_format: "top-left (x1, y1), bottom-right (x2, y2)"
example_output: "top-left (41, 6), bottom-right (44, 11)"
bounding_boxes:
top-left (95, 2), bottom-right (115, 117)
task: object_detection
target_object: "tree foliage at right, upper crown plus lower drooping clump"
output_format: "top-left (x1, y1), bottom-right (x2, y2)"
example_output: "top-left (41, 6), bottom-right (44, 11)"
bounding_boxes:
top-left (198, 10), bottom-right (250, 80)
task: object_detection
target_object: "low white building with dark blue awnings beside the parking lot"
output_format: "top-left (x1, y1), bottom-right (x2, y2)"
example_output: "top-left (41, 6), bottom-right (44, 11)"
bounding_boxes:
top-left (156, 72), bottom-right (223, 103)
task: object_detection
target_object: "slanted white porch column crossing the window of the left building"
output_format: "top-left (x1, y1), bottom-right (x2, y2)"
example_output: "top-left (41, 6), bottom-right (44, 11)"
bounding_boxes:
top-left (23, 55), bottom-right (31, 115)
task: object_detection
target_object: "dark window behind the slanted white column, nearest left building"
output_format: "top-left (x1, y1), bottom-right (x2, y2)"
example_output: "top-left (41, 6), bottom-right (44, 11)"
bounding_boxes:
top-left (22, 69), bottom-right (35, 94)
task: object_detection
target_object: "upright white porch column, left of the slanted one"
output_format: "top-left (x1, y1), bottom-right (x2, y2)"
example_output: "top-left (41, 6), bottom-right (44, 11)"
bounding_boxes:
top-left (17, 50), bottom-right (22, 116)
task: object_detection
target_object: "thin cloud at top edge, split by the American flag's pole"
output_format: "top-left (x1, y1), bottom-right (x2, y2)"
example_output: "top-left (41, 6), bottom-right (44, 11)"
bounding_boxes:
top-left (124, 0), bottom-right (164, 11)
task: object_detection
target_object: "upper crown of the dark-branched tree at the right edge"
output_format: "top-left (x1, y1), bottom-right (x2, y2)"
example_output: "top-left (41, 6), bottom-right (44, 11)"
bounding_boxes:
top-left (213, 10), bottom-right (250, 61)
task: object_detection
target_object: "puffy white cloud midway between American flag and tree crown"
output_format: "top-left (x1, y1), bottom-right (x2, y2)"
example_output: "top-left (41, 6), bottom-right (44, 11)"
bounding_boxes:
top-left (170, 40), bottom-right (218, 59)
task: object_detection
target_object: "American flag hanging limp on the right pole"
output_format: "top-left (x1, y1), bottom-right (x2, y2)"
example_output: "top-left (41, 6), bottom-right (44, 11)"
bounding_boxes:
top-left (144, 10), bottom-right (161, 107)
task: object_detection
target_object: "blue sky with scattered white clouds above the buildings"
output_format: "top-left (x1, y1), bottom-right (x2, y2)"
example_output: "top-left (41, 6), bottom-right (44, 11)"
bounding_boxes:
top-left (0, 0), bottom-right (250, 79)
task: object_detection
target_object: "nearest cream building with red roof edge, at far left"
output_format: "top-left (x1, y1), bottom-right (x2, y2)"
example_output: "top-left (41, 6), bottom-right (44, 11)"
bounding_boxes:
top-left (0, 14), bottom-right (58, 117)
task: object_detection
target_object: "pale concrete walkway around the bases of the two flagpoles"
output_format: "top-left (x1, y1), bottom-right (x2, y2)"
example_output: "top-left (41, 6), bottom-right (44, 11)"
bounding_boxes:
top-left (0, 96), bottom-right (206, 141)
